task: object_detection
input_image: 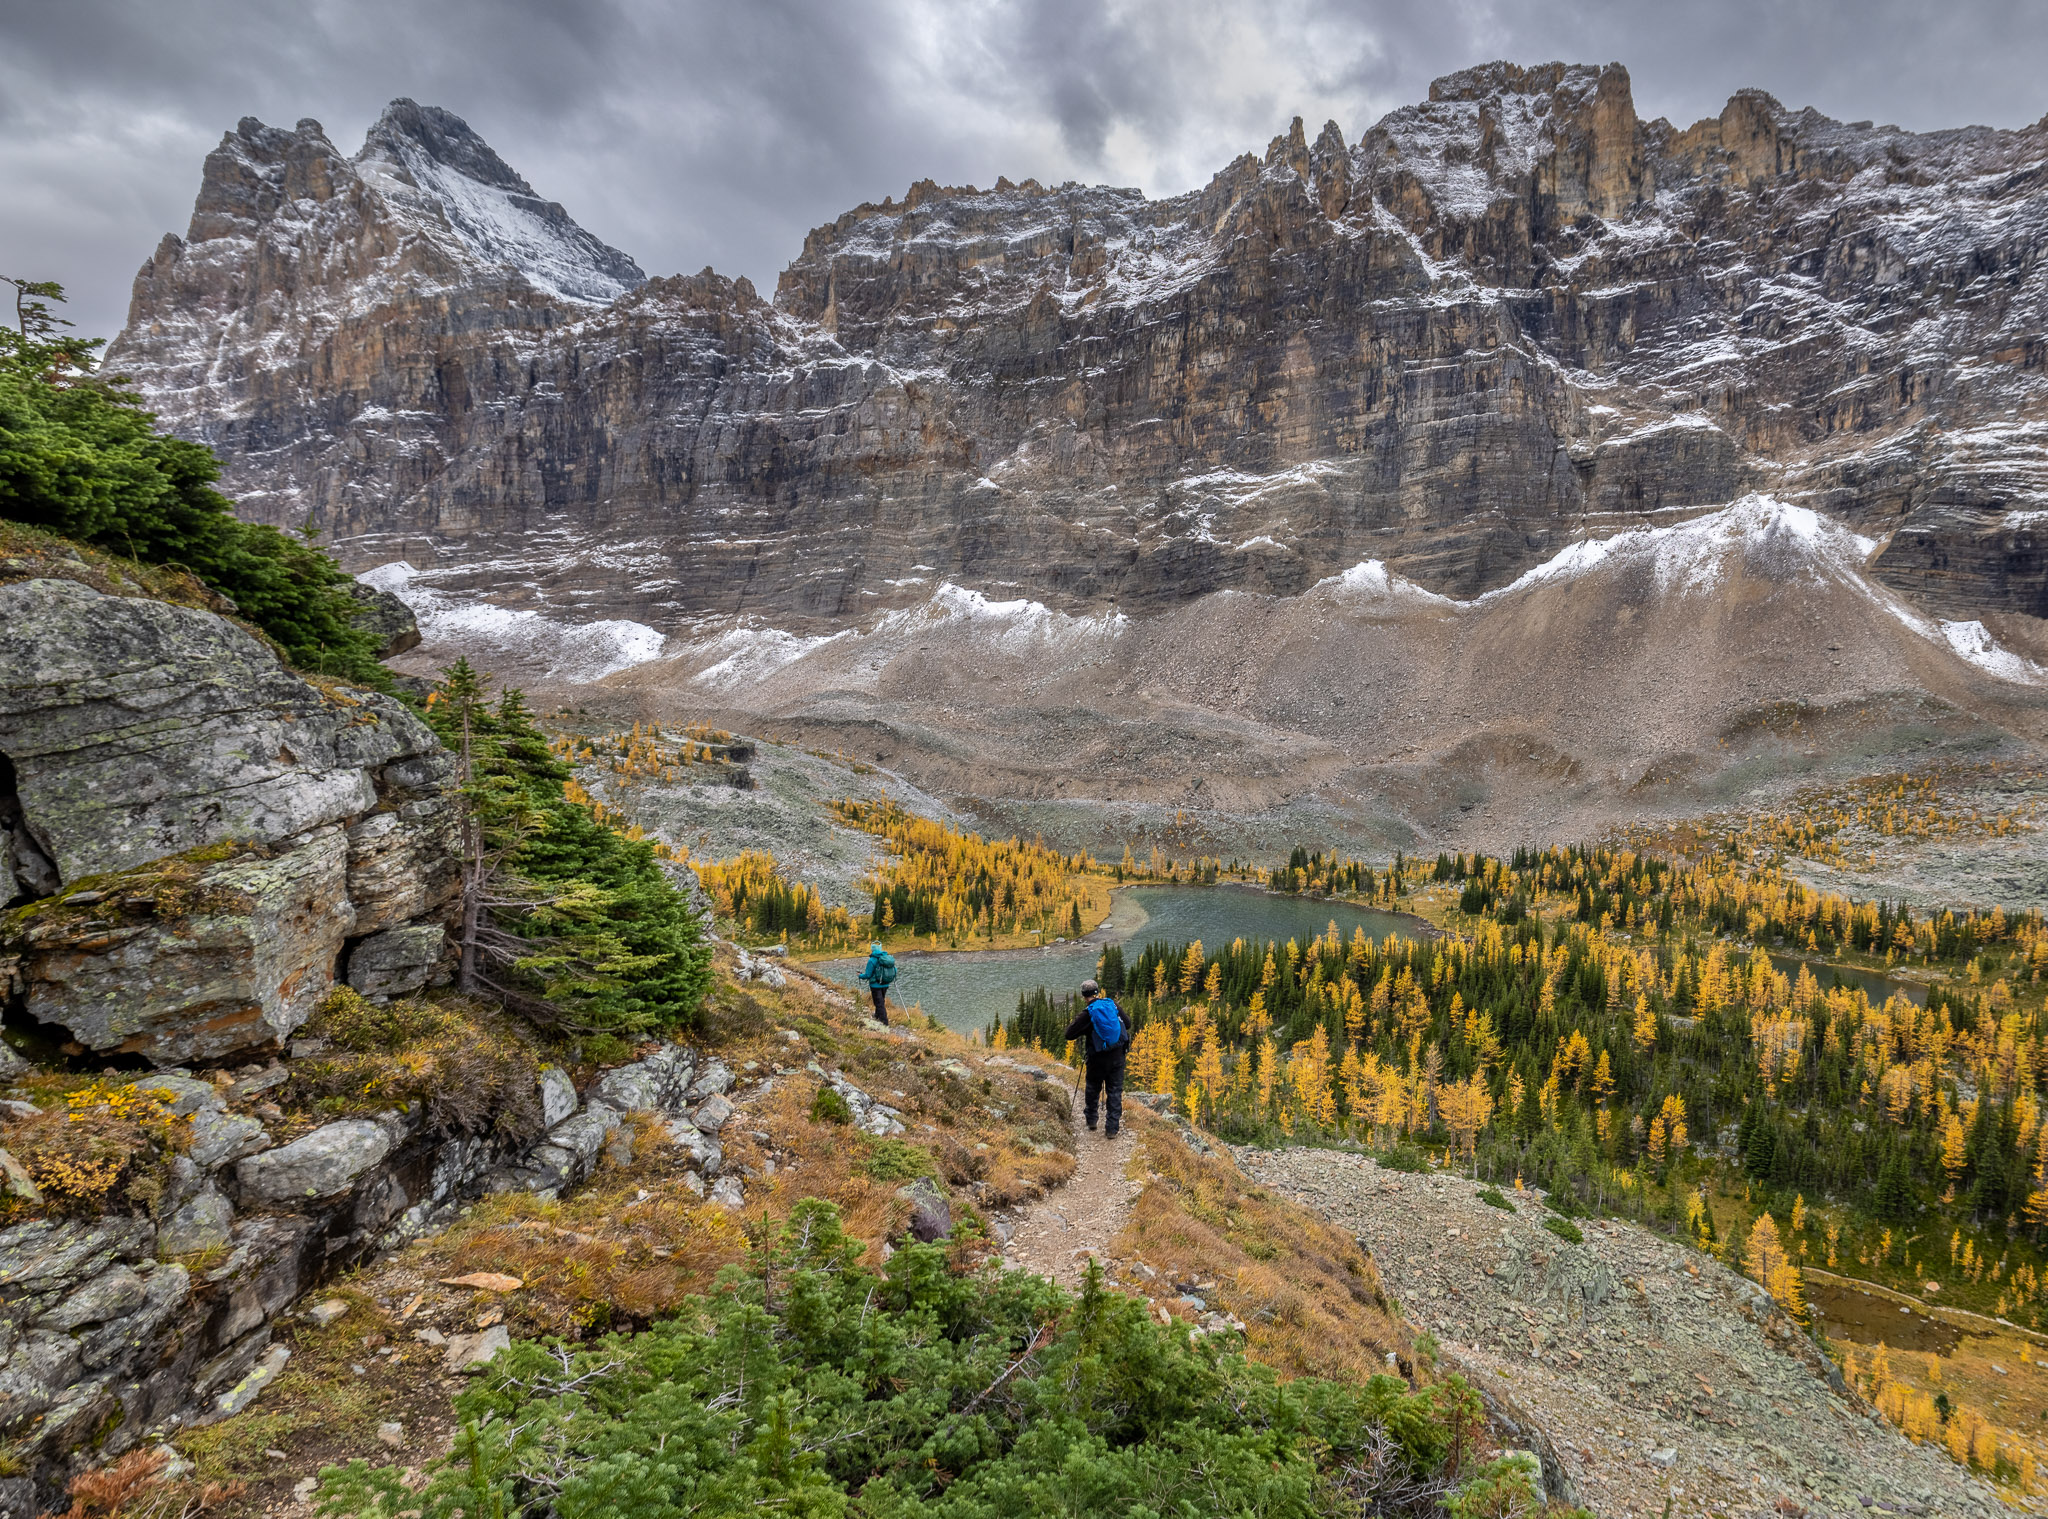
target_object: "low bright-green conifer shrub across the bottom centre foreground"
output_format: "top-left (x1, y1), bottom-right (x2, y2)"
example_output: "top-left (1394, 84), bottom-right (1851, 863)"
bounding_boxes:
top-left (317, 1198), bottom-right (1477, 1519)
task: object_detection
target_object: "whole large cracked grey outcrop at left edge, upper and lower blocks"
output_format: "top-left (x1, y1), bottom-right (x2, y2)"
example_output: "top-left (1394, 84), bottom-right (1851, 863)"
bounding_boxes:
top-left (0, 579), bottom-right (459, 1065)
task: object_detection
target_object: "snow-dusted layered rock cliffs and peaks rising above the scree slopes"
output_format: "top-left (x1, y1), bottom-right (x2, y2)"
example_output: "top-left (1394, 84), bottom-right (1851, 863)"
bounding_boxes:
top-left (111, 63), bottom-right (2048, 635)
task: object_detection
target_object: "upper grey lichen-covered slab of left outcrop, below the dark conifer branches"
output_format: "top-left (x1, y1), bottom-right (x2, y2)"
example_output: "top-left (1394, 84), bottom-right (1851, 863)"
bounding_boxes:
top-left (0, 579), bottom-right (438, 884)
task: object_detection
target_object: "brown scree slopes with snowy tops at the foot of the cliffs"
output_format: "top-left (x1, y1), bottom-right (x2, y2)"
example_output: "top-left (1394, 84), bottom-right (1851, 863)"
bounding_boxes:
top-left (608, 495), bottom-right (2048, 863)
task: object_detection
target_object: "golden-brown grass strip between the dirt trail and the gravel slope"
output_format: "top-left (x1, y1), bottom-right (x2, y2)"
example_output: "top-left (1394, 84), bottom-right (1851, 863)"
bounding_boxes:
top-left (1112, 1124), bottom-right (1415, 1382)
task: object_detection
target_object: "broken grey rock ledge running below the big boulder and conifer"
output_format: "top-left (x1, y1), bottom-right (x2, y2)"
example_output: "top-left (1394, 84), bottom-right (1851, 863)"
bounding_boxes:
top-left (0, 1046), bottom-right (743, 1513)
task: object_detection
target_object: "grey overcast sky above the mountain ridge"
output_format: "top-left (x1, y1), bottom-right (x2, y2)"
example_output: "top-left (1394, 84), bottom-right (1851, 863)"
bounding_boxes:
top-left (12, 0), bottom-right (2048, 336)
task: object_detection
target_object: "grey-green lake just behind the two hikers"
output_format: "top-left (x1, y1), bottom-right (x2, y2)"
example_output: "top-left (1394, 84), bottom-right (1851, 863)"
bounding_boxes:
top-left (811, 886), bottom-right (1430, 1034)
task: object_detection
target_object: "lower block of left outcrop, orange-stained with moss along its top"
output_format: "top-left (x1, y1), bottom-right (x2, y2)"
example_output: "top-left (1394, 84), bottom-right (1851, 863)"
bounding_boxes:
top-left (16, 825), bottom-right (356, 1065)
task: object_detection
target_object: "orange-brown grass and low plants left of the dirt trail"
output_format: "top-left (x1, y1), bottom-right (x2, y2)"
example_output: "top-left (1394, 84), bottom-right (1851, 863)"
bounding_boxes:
top-left (381, 962), bottom-right (1097, 1339)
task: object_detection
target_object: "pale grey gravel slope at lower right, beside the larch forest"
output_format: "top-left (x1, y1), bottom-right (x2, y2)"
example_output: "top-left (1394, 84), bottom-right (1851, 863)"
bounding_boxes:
top-left (1233, 1148), bottom-right (2003, 1519)
